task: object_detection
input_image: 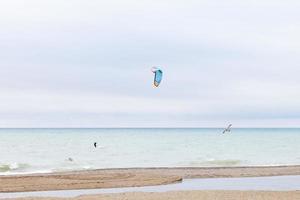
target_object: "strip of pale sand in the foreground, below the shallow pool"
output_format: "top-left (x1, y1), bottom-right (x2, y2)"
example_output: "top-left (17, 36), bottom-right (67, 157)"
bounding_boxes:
top-left (9, 190), bottom-right (300, 200)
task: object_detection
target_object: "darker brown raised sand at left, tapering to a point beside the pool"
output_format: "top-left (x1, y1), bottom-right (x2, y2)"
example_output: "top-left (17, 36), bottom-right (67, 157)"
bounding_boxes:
top-left (0, 170), bottom-right (181, 196)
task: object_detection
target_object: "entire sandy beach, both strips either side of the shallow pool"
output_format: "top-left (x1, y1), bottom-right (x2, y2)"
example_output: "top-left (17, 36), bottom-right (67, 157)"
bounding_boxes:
top-left (0, 166), bottom-right (300, 200)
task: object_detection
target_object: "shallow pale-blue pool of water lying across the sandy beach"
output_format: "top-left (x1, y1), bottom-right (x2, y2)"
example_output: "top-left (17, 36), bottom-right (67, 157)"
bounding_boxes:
top-left (0, 176), bottom-right (300, 199)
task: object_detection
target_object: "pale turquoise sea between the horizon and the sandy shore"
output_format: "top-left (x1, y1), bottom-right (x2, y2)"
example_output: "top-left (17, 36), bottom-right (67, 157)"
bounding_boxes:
top-left (0, 128), bottom-right (300, 174)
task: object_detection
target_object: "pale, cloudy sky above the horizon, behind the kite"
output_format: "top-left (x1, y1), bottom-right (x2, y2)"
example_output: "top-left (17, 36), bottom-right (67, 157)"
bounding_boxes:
top-left (0, 0), bottom-right (300, 127)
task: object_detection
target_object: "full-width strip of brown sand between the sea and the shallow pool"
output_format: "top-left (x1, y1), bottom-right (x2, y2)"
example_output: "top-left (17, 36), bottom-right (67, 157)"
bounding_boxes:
top-left (0, 165), bottom-right (300, 195)
